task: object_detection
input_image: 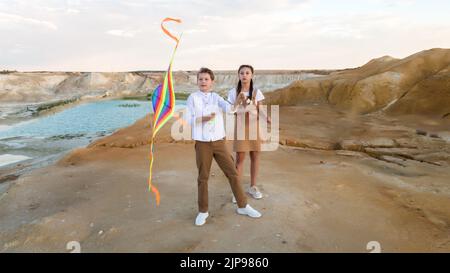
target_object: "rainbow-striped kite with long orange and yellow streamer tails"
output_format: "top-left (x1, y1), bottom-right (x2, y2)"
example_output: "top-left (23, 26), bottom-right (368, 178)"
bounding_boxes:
top-left (148, 18), bottom-right (181, 206)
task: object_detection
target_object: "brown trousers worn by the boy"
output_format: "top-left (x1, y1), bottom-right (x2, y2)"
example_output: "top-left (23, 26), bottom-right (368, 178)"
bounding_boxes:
top-left (195, 140), bottom-right (247, 212)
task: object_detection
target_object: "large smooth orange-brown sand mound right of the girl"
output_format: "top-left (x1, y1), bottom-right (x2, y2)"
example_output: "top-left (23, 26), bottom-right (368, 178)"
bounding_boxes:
top-left (266, 49), bottom-right (450, 117)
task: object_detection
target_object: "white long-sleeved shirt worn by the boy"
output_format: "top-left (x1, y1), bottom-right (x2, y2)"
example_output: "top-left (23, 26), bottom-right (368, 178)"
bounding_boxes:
top-left (187, 91), bottom-right (231, 141)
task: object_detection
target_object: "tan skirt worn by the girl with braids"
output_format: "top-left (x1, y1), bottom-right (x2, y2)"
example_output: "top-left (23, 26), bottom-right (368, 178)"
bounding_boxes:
top-left (233, 113), bottom-right (261, 152)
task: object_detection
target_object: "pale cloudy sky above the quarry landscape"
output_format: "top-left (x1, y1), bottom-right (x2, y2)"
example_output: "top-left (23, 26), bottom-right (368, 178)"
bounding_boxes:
top-left (0, 0), bottom-right (450, 72)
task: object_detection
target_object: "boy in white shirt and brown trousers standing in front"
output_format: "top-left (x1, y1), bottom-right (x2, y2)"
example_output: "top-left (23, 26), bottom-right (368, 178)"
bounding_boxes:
top-left (187, 68), bottom-right (261, 226)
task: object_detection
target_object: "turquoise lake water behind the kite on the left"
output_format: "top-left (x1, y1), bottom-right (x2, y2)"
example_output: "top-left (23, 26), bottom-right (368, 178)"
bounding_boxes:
top-left (0, 100), bottom-right (186, 167)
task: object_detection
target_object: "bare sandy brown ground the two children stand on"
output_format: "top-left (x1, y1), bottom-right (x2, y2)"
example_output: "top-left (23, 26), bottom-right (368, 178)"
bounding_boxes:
top-left (0, 106), bottom-right (450, 252)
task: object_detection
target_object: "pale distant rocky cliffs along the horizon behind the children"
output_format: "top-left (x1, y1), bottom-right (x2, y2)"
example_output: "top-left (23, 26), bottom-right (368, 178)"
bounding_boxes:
top-left (0, 71), bottom-right (329, 103)
